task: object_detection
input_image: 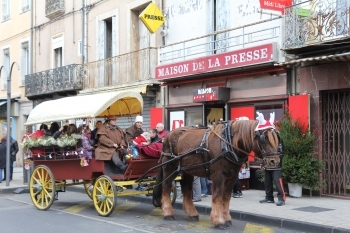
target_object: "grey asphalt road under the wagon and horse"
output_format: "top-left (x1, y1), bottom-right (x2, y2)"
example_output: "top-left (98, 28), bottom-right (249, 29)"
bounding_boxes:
top-left (0, 191), bottom-right (304, 233)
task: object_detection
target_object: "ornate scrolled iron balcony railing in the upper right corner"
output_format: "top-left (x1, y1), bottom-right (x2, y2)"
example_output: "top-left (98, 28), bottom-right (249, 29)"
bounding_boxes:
top-left (284, 0), bottom-right (350, 49)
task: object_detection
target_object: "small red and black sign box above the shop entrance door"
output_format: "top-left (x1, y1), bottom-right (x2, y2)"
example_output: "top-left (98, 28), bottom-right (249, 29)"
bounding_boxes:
top-left (193, 87), bottom-right (230, 103)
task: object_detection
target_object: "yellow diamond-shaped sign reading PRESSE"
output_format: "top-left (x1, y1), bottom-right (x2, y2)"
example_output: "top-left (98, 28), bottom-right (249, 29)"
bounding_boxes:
top-left (139, 2), bottom-right (165, 33)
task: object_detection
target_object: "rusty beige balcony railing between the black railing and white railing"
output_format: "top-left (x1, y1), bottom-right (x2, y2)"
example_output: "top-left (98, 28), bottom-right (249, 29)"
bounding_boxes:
top-left (84, 48), bottom-right (158, 89)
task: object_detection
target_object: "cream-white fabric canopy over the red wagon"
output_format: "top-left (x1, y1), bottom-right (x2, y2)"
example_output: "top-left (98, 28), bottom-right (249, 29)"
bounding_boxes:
top-left (25, 91), bottom-right (143, 125)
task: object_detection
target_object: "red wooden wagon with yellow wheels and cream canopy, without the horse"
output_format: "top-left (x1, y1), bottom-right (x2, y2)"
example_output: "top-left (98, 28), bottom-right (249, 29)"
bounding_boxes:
top-left (26, 91), bottom-right (176, 216)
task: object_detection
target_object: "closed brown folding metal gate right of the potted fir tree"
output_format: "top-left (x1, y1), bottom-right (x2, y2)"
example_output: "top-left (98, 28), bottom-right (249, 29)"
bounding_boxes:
top-left (321, 90), bottom-right (350, 197)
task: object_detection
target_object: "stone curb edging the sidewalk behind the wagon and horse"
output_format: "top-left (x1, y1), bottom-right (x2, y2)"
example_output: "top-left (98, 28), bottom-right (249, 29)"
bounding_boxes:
top-left (9, 186), bottom-right (350, 233)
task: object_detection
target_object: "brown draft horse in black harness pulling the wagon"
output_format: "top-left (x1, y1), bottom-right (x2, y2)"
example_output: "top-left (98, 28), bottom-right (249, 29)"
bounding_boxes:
top-left (153, 120), bottom-right (279, 229)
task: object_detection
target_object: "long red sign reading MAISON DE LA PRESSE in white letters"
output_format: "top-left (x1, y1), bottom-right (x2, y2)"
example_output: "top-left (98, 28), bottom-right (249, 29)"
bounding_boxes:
top-left (156, 43), bottom-right (277, 80)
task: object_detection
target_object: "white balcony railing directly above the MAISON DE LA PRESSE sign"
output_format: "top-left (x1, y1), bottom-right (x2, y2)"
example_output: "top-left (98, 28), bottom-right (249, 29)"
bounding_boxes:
top-left (159, 17), bottom-right (281, 64)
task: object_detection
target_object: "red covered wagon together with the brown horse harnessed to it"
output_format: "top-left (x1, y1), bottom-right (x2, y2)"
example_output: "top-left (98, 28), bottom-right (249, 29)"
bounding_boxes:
top-left (26, 89), bottom-right (282, 229)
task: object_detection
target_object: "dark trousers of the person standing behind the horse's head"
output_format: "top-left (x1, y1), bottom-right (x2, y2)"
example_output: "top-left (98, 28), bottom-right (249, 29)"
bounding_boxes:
top-left (265, 169), bottom-right (286, 201)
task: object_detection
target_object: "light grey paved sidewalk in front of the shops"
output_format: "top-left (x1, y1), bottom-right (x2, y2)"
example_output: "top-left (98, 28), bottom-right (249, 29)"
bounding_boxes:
top-left (0, 167), bottom-right (350, 233)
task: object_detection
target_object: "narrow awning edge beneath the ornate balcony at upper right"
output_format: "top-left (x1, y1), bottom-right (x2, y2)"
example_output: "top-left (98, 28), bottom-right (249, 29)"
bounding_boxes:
top-left (275, 52), bottom-right (350, 66)
